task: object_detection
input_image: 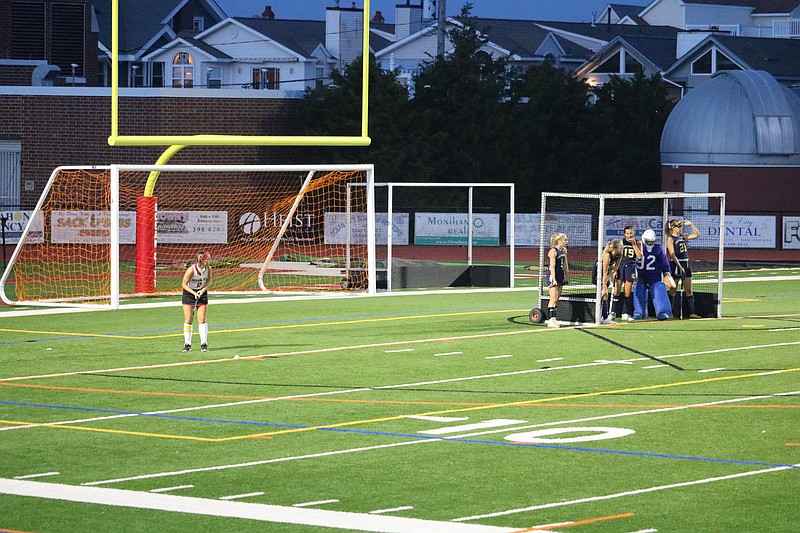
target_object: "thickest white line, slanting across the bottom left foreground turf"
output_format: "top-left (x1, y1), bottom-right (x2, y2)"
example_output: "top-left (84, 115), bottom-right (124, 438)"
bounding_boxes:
top-left (0, 478), bottom-right (519, 533)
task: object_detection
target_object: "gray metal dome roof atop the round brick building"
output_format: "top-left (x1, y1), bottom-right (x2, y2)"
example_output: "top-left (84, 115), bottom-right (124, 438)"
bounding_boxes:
top-left (661, 70), bottom-right (800, 166)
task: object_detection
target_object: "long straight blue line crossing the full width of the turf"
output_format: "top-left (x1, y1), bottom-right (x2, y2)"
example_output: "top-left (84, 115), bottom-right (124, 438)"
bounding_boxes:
top-left (0, 401), bottom-right (800, 469)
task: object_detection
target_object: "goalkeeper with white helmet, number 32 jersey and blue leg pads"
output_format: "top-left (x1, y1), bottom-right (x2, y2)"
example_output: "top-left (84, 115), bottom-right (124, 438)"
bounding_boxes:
top-left (633, 229), bottom-right (675, 320)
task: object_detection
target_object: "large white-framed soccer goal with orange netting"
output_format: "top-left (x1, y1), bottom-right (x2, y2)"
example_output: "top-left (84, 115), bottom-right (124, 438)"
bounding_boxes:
top-left (0, 165), bottom-right (375, 309)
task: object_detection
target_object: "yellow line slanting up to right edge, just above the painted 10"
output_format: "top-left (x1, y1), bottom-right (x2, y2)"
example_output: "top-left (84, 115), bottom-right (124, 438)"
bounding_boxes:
top-left (220, 368), bottom-right (800, 441)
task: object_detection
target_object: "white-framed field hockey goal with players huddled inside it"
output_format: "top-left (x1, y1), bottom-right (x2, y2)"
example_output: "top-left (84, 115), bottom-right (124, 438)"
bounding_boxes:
top-left (531, 192), bottom-right (725, 325)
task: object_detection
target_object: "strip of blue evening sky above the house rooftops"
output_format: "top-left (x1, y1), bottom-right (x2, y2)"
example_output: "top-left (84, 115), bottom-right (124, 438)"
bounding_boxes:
top-left (217, 0), bottom-right (652, 24)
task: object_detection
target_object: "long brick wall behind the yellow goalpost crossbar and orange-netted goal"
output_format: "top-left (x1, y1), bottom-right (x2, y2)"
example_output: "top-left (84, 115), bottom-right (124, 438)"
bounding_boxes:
top-left (0, 95), bottom-right (308, 209)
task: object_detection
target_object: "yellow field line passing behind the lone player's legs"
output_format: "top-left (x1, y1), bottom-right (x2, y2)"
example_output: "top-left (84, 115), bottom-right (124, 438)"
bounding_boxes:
top-left (0, 309), bottom-right (527, 340)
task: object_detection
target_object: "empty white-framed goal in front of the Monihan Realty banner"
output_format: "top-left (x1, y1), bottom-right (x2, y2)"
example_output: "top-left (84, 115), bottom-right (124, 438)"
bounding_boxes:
top-left (375, 182), bottom-right (515, 290)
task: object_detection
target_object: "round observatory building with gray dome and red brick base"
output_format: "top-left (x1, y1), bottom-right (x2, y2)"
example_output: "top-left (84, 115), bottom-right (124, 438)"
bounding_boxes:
top-left (661, 70), bottom-right (800, 256)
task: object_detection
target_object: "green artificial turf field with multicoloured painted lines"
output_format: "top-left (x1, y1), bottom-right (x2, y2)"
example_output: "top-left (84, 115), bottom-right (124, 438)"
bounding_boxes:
top-left (0, 269), bottom-right (800, 533)
